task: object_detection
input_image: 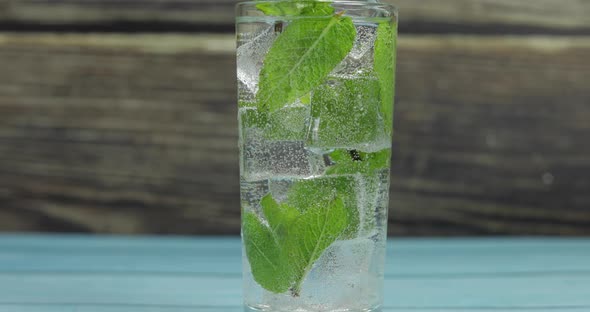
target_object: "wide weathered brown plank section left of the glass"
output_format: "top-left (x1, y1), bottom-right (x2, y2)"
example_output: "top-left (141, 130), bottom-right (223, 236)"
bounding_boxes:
top-left (0, 35), bottom-right (239, 233)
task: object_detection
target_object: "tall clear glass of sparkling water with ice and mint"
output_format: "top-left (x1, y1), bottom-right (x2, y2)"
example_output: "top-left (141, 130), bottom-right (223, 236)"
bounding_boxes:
top-left (237, 0), bottom-right (397, 312)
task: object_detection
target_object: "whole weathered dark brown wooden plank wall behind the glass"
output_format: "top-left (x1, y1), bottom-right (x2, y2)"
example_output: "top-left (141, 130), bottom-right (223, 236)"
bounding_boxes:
top-left (0, 0), bottom-right (590, 235)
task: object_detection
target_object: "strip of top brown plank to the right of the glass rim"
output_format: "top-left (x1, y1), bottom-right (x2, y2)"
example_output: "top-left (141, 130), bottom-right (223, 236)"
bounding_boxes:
top-left (394, 0), bottom-right (590, 35)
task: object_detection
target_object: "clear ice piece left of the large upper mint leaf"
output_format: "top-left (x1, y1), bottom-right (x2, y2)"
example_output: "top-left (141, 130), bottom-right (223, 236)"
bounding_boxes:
top-left (237, 24), bottom-right (277, 99)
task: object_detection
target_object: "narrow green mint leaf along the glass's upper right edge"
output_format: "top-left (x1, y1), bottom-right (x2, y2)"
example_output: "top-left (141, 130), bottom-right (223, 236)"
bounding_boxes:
top-left (374, 22), bottom-right (397, 134)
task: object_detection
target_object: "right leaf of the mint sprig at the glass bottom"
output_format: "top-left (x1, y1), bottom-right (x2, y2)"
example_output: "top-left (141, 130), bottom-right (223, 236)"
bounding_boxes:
top-left (284, 197), bottom-right (348, 297)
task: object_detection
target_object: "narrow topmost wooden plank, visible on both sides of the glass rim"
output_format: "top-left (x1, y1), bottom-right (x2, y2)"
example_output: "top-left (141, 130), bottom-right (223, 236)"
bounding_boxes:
top-left (0, 0), bottom-right (590, 35)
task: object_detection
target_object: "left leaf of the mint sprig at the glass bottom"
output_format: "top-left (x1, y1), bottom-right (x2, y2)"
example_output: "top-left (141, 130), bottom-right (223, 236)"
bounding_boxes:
top-left (242, 212), bottom-right (293, 293)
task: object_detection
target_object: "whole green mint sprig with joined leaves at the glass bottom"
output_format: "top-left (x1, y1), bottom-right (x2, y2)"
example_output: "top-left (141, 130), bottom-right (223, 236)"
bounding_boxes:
top-left (242, 194), bottom-right (348, 297)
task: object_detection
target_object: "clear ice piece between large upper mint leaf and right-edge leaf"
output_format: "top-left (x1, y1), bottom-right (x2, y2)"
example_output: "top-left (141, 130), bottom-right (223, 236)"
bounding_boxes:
top-left (330, 25), bottom-right (377, 78)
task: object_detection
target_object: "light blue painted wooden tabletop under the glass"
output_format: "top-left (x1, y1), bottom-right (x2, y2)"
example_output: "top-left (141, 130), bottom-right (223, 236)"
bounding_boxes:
top-left (0, 235), bottom-right (590, 312)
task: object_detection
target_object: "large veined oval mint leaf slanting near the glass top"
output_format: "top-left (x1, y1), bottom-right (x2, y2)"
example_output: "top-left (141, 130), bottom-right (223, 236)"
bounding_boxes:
top-left (256, 14), bottom-right (356, 112)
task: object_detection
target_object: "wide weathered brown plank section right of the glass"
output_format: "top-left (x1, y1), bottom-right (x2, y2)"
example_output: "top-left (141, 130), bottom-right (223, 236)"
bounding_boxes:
top-left (391, 37), bottom-right (590, 234)
